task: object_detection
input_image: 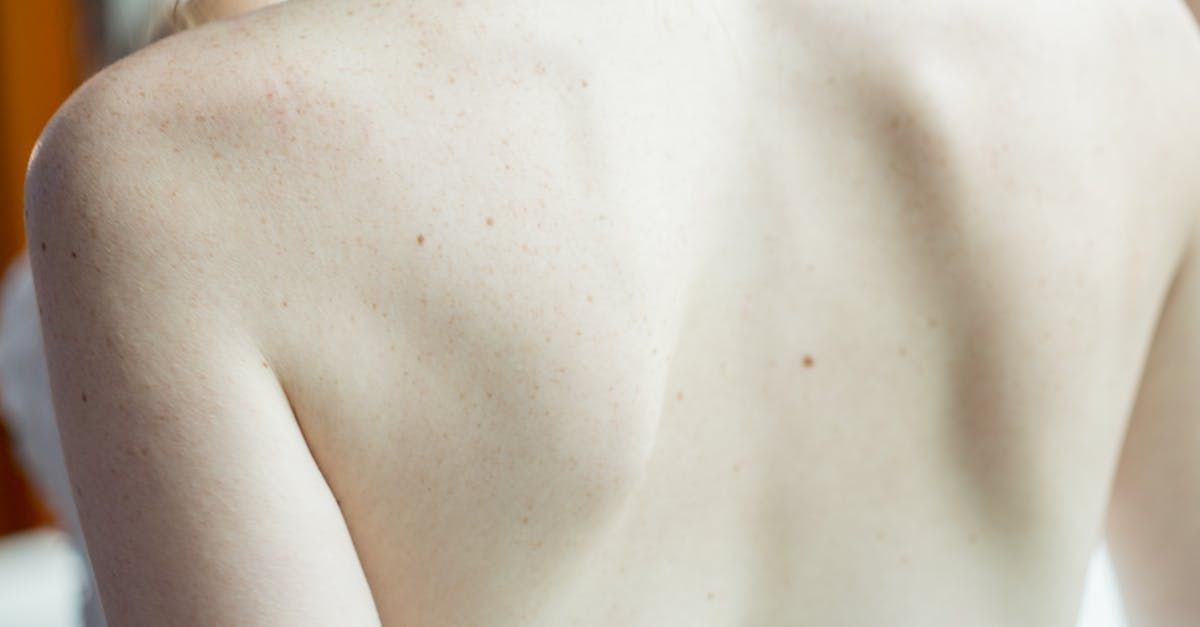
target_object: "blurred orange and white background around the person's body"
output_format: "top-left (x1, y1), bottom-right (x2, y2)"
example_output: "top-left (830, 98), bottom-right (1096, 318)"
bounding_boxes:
top-left (0, 0), bottom-right (1126, 627)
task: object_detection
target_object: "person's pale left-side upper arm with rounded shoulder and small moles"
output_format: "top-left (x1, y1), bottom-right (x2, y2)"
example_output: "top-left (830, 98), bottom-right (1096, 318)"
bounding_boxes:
top-left (26, 62), bottom-right (378, 626)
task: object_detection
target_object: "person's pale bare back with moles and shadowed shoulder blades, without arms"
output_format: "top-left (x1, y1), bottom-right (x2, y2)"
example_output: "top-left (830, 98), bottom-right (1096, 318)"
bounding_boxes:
top-left (23, 0), bottom-right (1200, 627)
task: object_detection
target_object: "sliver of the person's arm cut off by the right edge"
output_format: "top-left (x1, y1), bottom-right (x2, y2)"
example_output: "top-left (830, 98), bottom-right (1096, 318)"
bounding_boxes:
top-left (1109, 216), bottom-right (1200, 627)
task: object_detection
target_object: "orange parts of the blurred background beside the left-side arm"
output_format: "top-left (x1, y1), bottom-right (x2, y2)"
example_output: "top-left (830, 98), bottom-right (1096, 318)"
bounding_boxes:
top-left (0, 0), bottom-right (86, 535)
